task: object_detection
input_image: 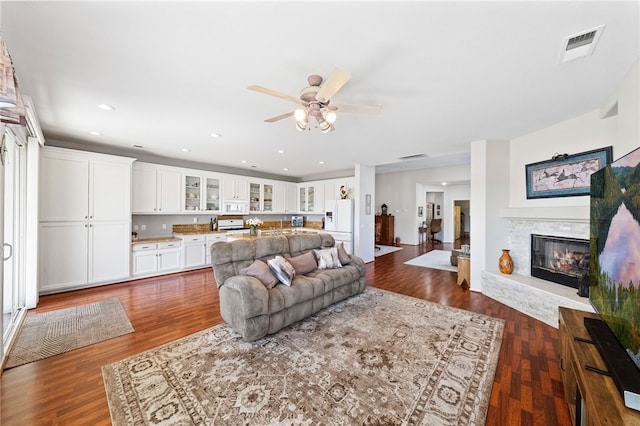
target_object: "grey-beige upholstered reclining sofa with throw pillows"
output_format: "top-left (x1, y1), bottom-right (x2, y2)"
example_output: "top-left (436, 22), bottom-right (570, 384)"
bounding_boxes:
top-left (211, 233), bottom-right (366, 341)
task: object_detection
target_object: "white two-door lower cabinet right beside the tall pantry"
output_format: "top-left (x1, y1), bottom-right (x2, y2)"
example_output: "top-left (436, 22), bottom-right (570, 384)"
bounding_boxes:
top-left (131, 241), bottom-right (182, 276)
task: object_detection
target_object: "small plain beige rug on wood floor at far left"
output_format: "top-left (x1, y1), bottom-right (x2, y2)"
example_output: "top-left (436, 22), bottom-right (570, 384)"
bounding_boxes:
top-left (5, 299), bottom-right (134, 368)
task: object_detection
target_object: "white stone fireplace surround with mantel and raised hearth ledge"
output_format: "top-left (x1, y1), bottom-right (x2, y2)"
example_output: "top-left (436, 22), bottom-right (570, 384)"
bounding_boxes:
top-left (482, 207), bottom-right (594, 328)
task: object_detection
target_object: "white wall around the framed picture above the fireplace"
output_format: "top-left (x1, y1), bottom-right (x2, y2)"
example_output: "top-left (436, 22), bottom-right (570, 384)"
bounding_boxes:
top-left (471, 54), bottom-right (640, 290)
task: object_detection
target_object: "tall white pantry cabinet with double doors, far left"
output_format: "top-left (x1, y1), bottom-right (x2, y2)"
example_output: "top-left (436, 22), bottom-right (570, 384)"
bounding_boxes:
top-left (38, 147), bottom-right (134, 293)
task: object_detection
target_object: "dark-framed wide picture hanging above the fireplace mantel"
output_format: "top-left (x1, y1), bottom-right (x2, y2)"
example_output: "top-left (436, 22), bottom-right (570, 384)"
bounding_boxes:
top-left (525, 146), bottom-right (613, 199)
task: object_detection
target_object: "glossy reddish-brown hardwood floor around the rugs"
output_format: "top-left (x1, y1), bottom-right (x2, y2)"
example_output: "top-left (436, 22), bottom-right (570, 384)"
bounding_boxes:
top-left (0, 242), bottom-right (571, 426)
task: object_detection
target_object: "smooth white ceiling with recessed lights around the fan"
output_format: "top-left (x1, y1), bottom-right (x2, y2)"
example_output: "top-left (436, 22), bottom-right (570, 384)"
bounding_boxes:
top-left (0, 1), bottom-right (640, 180)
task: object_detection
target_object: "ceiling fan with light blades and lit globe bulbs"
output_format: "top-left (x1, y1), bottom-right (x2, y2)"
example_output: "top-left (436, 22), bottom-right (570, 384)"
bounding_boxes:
top-left (248, 68), bottom-right (382, 133)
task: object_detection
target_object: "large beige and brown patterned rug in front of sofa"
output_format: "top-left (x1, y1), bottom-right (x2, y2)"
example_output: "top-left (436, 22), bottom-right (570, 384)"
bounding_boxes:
top-left (102, 288), bottom-right (504, 425)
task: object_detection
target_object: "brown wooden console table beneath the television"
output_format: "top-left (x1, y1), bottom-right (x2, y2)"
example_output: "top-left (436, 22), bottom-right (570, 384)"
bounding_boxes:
top-left (558, 307), bottom-right (640, 426)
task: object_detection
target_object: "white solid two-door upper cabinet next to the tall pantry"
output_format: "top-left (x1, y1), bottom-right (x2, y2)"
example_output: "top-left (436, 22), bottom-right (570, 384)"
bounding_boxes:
top-left (132, 162), bottom-right (182, 214)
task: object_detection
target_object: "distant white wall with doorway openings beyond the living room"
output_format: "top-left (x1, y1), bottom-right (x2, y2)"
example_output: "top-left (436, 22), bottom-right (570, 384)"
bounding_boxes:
top-left (376, 165), bottom-right (470, 244)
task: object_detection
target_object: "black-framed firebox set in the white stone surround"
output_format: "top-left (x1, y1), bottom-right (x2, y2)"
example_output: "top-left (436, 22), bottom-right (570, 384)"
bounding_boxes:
top-left (531, 234), bottom-right (589, 297)
